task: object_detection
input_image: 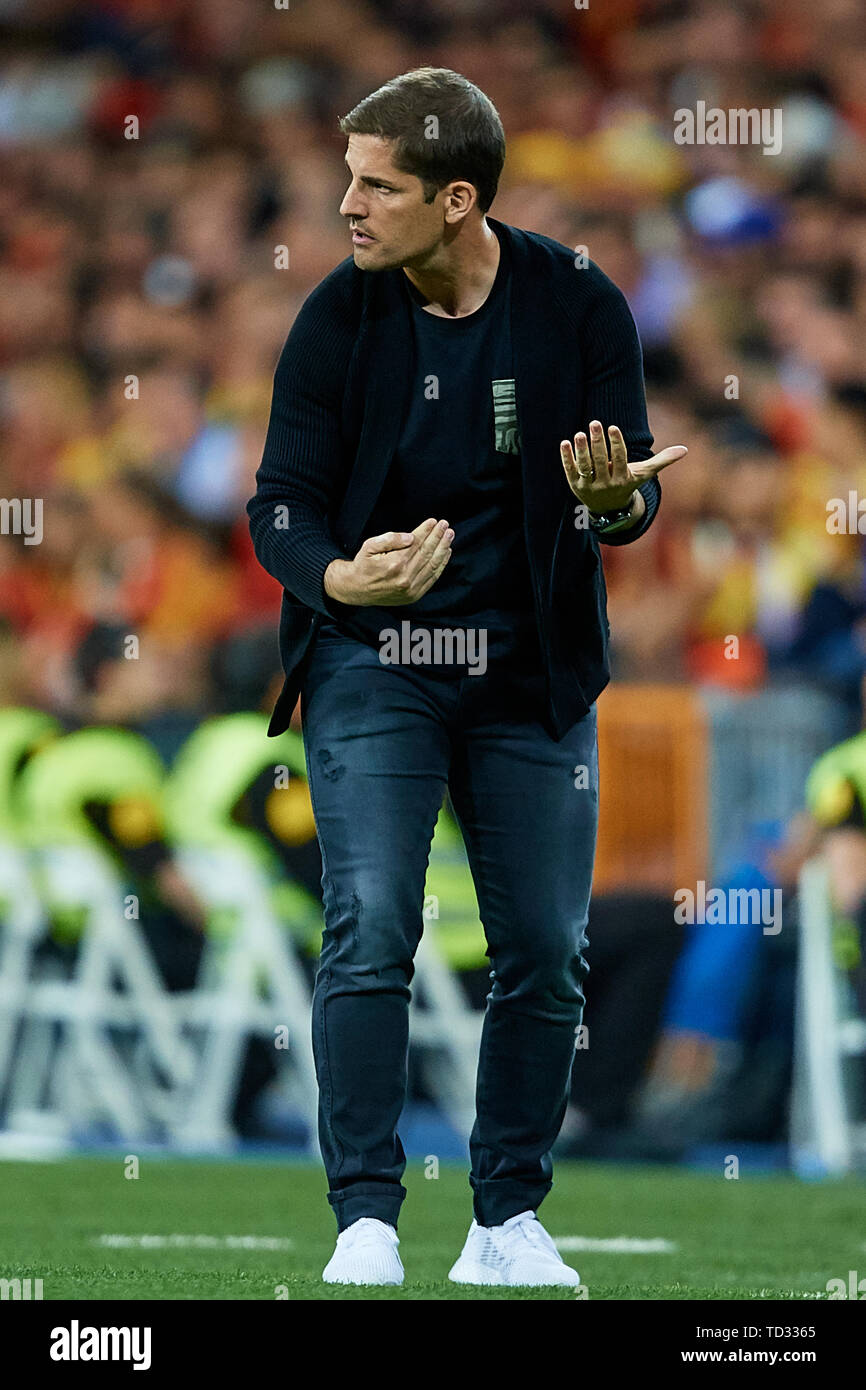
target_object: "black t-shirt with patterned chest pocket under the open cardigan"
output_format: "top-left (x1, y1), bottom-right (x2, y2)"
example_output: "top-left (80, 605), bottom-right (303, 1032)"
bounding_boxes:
top-left (327, 225), bottom-right (541, 666)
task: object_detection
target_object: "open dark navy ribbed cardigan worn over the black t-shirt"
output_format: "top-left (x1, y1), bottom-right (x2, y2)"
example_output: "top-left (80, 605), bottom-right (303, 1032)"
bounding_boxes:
top-left (247, 217), bottom-right (662, 738)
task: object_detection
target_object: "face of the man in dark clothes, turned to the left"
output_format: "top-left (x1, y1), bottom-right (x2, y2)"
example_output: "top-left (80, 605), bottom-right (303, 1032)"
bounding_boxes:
top-left (339, 135), bottom-right (448, 270)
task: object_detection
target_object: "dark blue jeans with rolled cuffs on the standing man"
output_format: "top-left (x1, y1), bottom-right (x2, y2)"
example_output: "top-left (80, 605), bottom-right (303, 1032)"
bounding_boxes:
top-left (302, 628), bottom-right (598, 1230)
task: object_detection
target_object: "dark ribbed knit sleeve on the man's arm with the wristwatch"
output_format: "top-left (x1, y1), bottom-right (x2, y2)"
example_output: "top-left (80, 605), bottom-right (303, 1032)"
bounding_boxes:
top-left (578, 275), bottom-right (662, 545)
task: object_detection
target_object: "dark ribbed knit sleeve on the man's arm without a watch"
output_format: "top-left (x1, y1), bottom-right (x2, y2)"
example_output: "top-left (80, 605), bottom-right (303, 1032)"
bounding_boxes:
top-left (246, 267), bottom-right (353, 614)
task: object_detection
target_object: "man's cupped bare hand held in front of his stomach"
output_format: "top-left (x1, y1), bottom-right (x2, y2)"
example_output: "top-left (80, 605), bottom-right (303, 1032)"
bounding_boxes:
top-left (324, 517), bottom-right (455, 607)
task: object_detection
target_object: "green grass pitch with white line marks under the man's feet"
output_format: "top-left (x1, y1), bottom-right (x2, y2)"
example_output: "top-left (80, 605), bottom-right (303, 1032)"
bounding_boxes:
top-left (0, 1155), bottom-right (866, 1300)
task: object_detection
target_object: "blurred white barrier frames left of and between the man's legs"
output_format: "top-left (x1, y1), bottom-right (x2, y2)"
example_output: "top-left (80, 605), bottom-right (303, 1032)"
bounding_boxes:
top-left (0, 845), bottom-right (482, 1151)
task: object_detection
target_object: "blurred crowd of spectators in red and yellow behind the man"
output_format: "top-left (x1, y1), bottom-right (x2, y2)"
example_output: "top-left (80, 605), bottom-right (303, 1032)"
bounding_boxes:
top-left (0, 0), bottom-right (866, 753)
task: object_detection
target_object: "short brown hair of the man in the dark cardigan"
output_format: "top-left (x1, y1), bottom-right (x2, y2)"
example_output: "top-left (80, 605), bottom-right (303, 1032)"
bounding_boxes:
top-left (339, 68), bottom-right (505, 213)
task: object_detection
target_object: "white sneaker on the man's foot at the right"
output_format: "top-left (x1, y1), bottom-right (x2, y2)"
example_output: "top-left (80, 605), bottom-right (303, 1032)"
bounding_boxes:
top-left (448, 1212), bottom-right (580, 1287)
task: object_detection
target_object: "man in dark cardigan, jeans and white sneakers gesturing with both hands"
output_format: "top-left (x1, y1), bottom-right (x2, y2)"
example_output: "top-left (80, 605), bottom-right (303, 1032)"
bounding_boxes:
top-left (249, 68), bottom-right (685, 1284)
